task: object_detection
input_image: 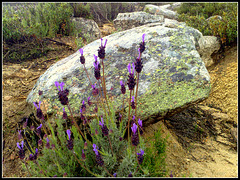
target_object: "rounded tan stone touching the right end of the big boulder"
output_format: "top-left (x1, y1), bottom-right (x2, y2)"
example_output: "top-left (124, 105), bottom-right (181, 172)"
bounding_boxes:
top-left (198, 36), bottom-right (221, 67)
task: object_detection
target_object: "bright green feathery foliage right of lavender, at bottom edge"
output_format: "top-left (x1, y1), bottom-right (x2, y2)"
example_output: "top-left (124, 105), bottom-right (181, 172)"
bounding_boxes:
top-left (142, 128), bottom-right (167, 177)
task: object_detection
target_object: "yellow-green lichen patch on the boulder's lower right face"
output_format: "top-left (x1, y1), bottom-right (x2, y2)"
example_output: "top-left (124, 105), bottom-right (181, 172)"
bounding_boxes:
top-left (139, 77), bottom-right (210, 119)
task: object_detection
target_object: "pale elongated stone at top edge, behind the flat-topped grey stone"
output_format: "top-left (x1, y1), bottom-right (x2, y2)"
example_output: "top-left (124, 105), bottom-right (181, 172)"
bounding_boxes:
top-left (143, 4), bottom-right (178, 19)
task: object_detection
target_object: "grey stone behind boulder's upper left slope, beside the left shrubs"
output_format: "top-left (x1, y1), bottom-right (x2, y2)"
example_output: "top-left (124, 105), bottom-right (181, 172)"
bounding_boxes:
top-left (71, 17), bottom-right (102, 42)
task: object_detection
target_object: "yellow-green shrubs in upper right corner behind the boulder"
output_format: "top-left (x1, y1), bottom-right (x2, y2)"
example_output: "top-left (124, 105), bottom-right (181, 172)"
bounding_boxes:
top-left (177, 3), bottom-right (237, 45)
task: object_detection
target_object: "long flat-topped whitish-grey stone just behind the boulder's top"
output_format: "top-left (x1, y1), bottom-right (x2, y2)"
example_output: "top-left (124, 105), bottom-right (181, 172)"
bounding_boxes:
top-left (113, 11), bottom-right (164, 30)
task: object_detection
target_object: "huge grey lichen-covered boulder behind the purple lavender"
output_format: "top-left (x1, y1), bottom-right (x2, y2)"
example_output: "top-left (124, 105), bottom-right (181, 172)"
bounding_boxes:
top-left (27, 23), bottom-right (211, 123)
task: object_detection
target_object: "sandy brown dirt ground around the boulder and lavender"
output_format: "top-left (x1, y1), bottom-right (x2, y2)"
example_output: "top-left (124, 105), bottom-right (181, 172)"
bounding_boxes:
top-left (2, 32), bottom-right (238, 177)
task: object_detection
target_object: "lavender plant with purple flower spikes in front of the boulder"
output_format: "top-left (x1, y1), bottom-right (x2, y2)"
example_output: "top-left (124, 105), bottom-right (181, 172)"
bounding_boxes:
top-left (17, 34), bottom-right (167, 177)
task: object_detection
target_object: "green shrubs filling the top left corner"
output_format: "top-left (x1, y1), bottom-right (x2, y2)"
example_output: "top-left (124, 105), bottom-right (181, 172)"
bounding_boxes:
top-left (3, 3), bottom-right (73, 42)
